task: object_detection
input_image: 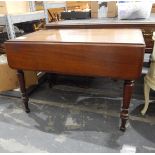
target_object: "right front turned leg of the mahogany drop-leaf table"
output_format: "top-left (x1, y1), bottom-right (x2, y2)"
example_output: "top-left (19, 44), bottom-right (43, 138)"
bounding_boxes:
top-left (120, 80), bottom-right (134, 131)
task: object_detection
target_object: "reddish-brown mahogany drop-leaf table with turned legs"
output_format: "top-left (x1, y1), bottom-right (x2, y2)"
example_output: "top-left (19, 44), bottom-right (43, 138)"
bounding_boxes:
top-left (5, 29), bottom-right (145, 131)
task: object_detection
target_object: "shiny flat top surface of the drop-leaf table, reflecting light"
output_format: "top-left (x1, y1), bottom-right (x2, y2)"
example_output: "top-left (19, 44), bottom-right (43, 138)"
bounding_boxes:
top-left (9, 29), bottom-right (145, 44)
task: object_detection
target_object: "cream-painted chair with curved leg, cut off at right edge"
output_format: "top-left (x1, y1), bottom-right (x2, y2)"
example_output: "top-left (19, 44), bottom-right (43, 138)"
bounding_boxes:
top-left (141, 32), bottom-right (155, 115)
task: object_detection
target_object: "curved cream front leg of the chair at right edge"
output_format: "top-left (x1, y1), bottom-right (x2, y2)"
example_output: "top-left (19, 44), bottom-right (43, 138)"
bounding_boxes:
top-left (141, 82), bottom-right (150, 115)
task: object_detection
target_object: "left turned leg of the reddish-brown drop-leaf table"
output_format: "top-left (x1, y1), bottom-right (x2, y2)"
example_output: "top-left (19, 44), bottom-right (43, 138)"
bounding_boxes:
top-left (17, 70), bottom-right (30, 113)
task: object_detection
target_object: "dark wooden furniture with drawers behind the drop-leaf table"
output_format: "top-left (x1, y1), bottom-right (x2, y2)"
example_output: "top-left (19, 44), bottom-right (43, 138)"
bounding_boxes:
top-left (46, 17), bottom-right (155, 53)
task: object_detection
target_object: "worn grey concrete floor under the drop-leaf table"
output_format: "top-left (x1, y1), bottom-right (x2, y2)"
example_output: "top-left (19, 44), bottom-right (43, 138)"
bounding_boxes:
top-left (0, 76), bottom-right (155, 153)
